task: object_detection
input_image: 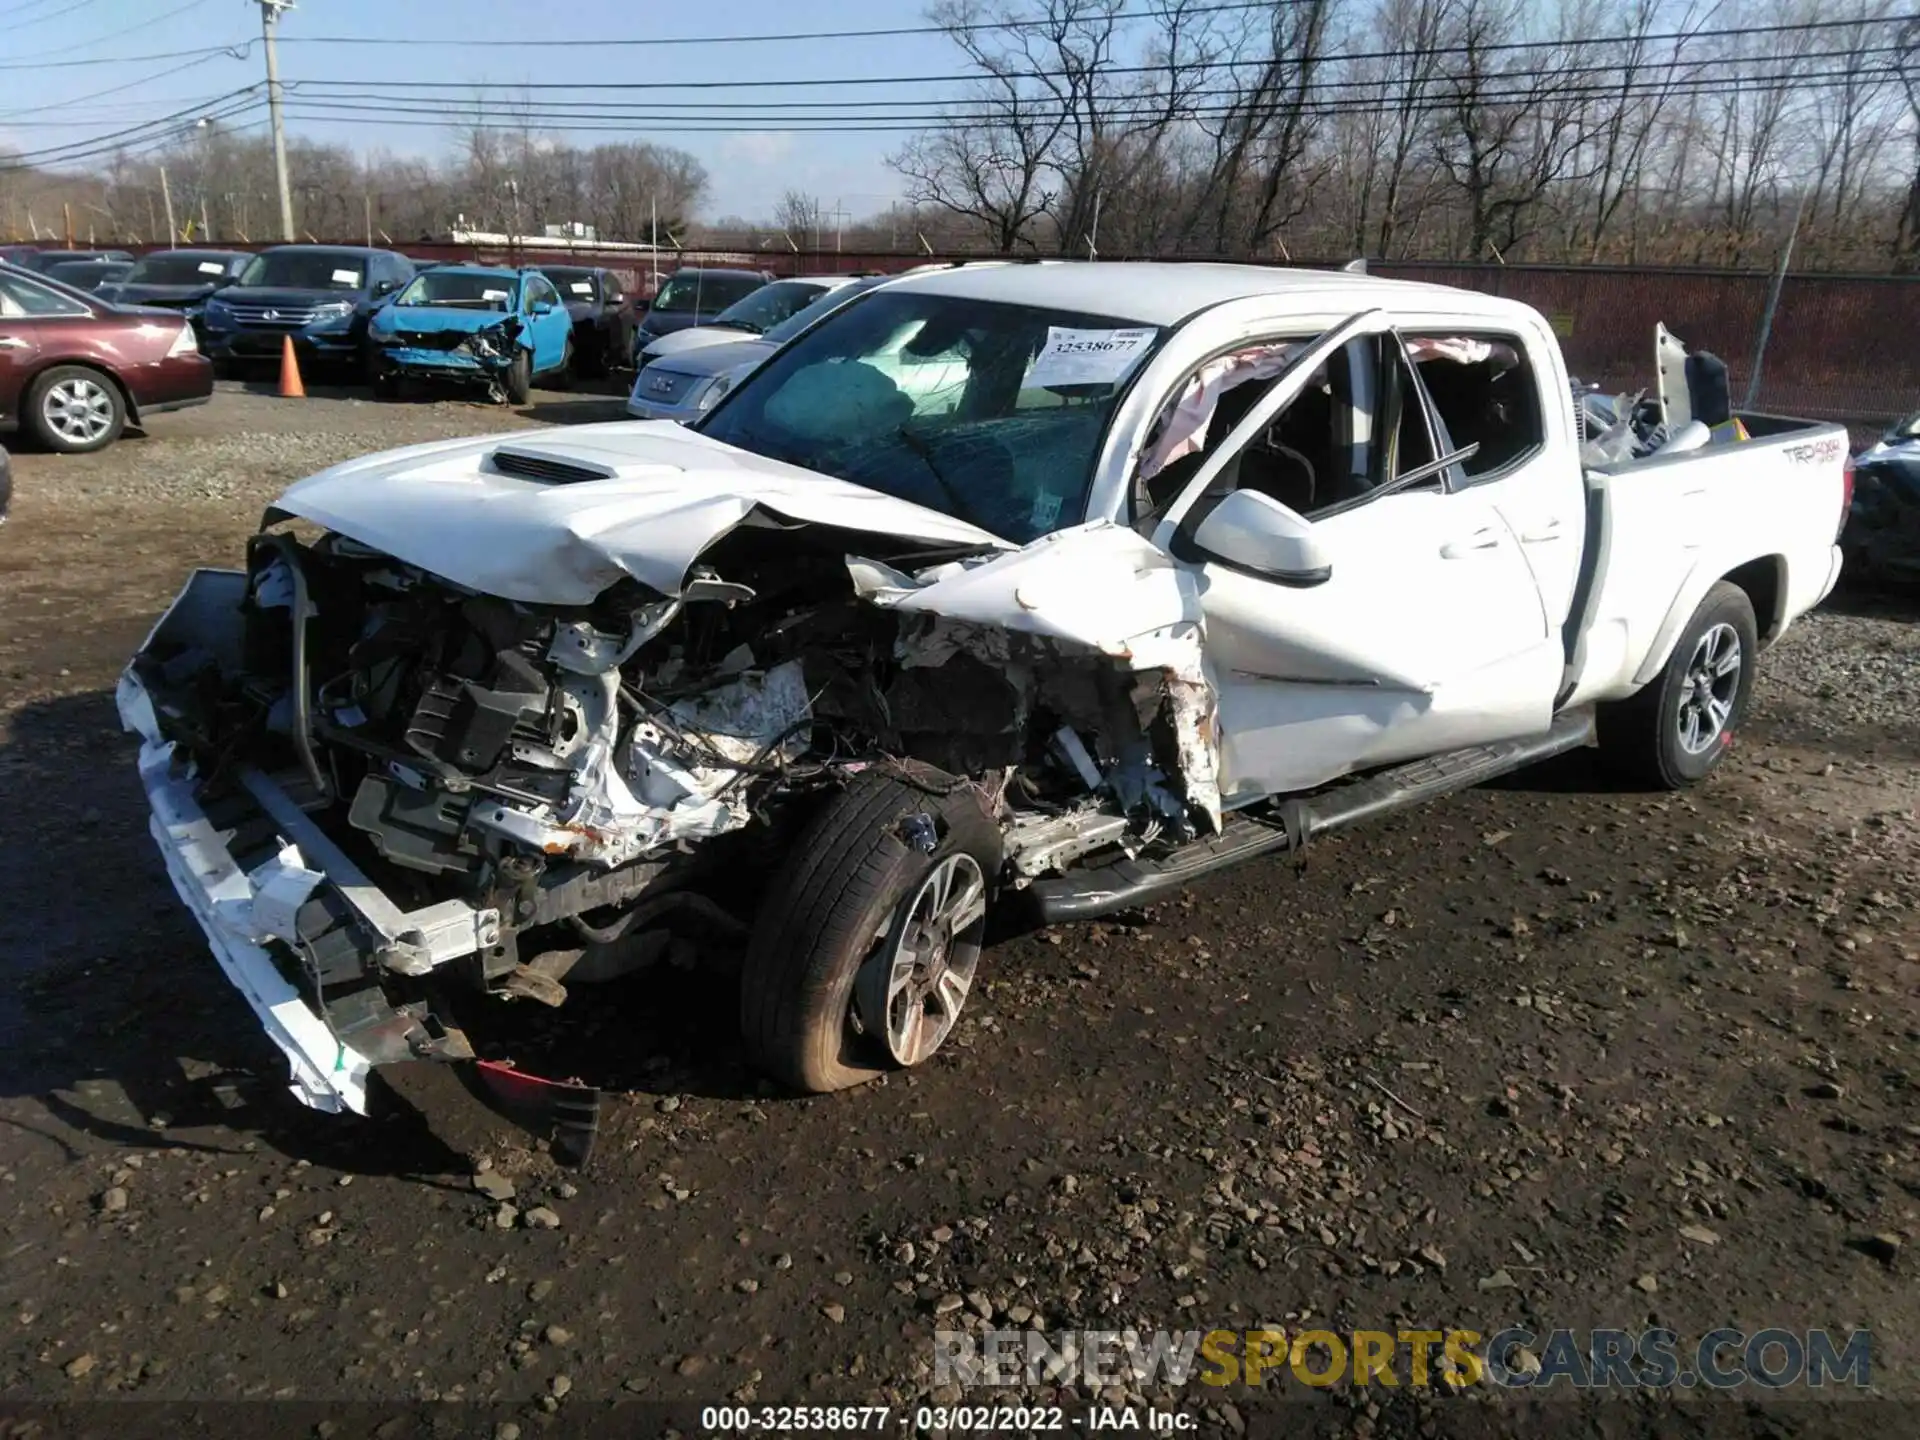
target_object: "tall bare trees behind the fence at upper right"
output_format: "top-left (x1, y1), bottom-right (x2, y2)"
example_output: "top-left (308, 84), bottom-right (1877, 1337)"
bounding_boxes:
top-left (893, 0), bottom-right (1920, 269)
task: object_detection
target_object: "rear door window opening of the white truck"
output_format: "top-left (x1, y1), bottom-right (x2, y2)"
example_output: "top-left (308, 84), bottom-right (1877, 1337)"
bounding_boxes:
top-left (1407, 334), bottom-right (1546, 484)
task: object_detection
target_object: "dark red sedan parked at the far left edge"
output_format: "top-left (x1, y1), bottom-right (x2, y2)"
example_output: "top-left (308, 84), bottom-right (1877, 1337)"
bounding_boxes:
top-left (0, 263), bottom-right (213, 455)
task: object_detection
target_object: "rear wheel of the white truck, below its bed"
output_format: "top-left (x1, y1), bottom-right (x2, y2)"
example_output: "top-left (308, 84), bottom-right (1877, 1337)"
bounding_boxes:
top-left (1599, 580), bottom-right (1761, 789)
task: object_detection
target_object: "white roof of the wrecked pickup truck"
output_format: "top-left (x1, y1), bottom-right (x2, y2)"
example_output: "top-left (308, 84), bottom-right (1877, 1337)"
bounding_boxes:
top-left (889, 261), bottom-right (1532, 324)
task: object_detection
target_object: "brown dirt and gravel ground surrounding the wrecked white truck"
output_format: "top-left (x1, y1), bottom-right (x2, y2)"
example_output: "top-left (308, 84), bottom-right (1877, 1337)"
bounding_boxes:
top-left (0, 386), bottom-right (1920, 1434)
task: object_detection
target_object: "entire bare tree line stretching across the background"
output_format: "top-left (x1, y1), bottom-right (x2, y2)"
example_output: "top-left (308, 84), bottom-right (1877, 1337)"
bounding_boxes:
top-left (0, 0), bottom-right (1920, 271)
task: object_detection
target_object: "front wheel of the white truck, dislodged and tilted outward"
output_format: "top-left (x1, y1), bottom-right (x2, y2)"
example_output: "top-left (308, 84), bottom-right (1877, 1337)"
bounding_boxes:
top-left (741, 776), bottom-right (1000, 1094)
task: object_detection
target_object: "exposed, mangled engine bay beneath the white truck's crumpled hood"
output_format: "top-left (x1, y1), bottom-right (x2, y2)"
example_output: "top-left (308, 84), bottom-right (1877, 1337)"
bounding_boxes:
top-left (132, 506), bottom-right (1217, 1090)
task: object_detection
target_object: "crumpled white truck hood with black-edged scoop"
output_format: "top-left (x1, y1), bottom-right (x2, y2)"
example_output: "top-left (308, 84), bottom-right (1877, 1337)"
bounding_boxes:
top-left (273, 420), bottom-right (1012, 605)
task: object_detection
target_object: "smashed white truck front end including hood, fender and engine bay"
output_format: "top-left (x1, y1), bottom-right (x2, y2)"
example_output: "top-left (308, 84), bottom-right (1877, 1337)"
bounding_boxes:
top-left (119, 426), bottom-right (1219, 1112)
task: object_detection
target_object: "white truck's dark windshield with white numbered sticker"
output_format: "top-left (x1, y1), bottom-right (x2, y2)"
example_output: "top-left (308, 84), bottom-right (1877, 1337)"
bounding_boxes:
top-left (701, 290), bottom-right (1162, 543)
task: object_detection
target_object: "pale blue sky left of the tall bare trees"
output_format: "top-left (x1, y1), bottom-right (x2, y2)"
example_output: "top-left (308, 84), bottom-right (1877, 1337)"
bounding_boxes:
top-left (0, 0), bottom-right (960, 217)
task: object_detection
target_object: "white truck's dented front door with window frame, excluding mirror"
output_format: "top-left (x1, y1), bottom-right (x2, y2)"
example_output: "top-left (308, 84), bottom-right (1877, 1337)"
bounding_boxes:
top-left (1154, 311), bottom-right (1563, 806)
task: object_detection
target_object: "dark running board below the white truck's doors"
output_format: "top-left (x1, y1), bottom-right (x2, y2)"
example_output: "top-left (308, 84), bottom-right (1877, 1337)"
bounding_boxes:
top-left (1027, 710), bottom-right (1594, 925)
